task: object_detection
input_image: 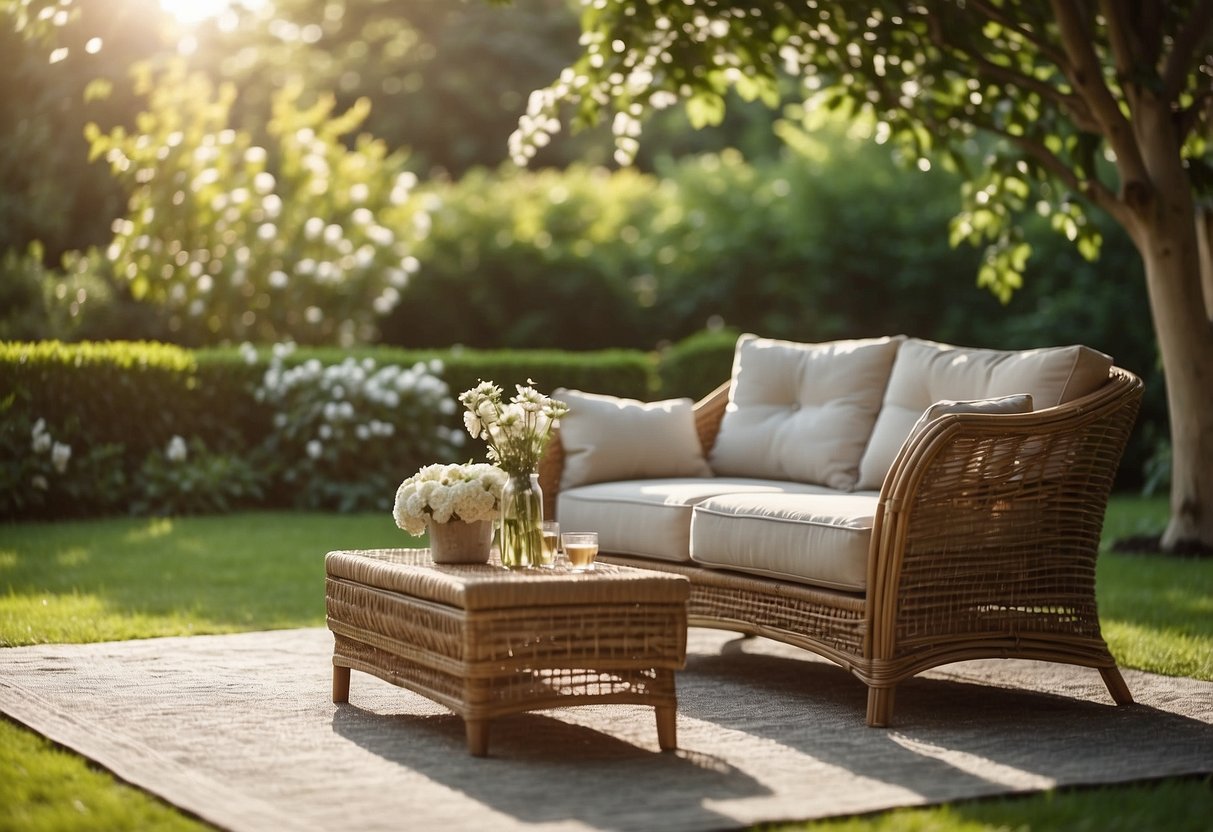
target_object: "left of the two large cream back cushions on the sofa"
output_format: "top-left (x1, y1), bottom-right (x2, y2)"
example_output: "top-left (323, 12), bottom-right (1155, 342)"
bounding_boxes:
top-left (708, 335), bottom-right (902, 491)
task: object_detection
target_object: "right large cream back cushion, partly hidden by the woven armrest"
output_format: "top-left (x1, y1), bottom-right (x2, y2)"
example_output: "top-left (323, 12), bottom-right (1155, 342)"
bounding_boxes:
top-left (859, 338), bottom-right (1112, 489)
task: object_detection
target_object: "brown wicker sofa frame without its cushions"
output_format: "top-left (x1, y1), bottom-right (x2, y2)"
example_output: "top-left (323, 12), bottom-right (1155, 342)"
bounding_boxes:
top-left (540, 336), bottom-right (1141, 726)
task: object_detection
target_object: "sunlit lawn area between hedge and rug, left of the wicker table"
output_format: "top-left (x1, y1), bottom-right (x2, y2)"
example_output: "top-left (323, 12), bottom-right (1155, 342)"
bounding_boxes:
top-left (0, 512), bottom-right (407, 646)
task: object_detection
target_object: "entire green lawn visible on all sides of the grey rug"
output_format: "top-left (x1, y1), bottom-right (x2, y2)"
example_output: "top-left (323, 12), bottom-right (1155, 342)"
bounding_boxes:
top-left (0, 497), bottom-right (1213, 832)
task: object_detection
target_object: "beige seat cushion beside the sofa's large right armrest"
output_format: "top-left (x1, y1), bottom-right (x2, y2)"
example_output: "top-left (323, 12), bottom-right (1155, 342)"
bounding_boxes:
top-left (691, 492), bottom-right (879, 592)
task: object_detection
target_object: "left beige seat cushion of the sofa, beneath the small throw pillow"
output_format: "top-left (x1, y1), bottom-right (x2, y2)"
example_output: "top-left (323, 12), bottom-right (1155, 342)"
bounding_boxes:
top-left (556, 478), bottom-right (844, 563)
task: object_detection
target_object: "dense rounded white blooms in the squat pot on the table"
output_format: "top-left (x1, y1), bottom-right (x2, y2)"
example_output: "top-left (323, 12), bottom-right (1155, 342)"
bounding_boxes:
top-left (392, 462), bottom-right (506, 536)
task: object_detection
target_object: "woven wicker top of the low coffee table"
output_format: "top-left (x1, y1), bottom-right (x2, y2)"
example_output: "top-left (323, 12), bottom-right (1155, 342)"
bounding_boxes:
top-left (324, 549), bottom-right (690, 610)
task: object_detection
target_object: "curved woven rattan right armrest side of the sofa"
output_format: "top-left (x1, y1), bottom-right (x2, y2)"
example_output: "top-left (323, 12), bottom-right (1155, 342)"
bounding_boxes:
top-left (869, 367), bottom-right (1141, 699)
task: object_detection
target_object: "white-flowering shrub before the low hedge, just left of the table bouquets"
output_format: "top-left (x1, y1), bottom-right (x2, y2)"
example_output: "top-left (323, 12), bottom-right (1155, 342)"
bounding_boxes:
top-left (255, 343), bottom-right (463, 511)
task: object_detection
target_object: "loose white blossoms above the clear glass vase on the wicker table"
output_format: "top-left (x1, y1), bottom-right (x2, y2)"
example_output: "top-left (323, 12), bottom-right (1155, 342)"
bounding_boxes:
top-left (459, 381), bottom-right (569, 473)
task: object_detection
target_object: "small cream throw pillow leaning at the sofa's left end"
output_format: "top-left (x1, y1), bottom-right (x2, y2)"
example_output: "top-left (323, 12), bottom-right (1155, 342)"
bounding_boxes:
top-left (552, 388), bottom-right (712, 490)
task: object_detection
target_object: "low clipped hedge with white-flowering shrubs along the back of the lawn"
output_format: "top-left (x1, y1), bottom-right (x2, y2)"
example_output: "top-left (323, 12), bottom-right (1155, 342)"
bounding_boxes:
top-left (0, 334), bottom-right (735, 519)
